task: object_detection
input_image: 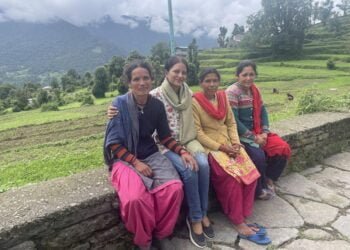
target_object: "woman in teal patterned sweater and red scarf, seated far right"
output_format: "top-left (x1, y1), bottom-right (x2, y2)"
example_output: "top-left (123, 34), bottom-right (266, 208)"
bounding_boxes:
top-left (226, 60), bottom-right (291, 200)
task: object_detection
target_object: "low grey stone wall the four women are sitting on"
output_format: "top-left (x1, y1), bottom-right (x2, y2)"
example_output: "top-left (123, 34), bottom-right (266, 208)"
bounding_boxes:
top-left (0, 113), bottom-right (350, 250)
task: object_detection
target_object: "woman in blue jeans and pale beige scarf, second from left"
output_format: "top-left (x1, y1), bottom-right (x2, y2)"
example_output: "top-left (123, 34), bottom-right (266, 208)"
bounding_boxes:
top-left (108, 56), bottom-right (215, 248)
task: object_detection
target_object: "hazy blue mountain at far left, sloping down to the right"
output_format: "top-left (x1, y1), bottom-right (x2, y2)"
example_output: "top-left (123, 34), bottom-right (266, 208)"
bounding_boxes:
top-left (0, 21), bottom-right (126, 84)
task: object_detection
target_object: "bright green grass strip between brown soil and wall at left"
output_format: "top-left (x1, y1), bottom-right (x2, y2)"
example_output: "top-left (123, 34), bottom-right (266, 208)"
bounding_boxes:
top-left (0, 134), bottom-right (103, 192)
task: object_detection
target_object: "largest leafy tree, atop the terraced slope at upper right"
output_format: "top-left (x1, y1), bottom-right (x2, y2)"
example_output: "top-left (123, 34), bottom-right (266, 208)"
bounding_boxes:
top-left (247, 0), bottom-right (312, 57)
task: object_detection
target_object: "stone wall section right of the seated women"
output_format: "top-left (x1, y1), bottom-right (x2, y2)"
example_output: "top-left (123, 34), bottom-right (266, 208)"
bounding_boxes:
top-left (271, 112), bottom-right (350, 172)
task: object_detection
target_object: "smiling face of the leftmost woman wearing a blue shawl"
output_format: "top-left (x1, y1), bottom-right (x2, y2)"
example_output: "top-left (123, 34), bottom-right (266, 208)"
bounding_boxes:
top-left (129, 67), bottom-right (152, 97)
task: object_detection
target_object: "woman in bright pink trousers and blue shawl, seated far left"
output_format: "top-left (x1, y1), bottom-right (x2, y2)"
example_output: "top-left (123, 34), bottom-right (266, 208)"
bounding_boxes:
top-left (104, 61), bottom-right (195, 249)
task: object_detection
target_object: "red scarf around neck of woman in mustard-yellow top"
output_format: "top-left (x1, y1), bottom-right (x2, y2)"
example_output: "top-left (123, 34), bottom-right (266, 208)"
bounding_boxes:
top-left (193, 91), bottom-right (227, 120)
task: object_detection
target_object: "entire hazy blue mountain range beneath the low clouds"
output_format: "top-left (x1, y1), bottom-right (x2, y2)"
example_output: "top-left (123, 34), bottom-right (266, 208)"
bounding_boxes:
top-left (0, 17), bottom-right (215, 84)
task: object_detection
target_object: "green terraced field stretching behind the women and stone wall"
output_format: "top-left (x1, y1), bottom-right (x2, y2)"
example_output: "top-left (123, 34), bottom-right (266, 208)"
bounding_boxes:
top-left (0, 17), bottom-right (350, 192)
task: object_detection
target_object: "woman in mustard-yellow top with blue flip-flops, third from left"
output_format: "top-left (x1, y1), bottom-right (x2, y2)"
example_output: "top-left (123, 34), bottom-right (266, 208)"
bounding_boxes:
top-left (193, 68), bottom-right (270, 244)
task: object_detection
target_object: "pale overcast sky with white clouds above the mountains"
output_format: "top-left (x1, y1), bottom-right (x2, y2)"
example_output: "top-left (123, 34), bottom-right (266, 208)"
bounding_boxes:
top-left (0, 0), bottom-right (261, 37)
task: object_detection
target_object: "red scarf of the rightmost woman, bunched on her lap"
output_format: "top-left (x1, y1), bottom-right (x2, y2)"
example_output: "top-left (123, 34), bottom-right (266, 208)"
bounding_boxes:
top-left (250, 84), bottom-right (291, 158)
